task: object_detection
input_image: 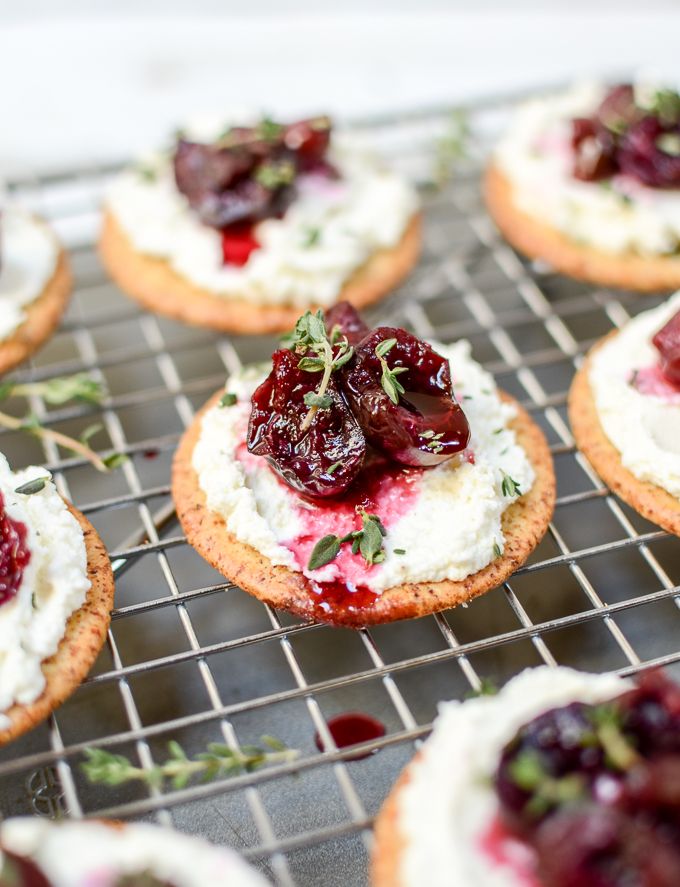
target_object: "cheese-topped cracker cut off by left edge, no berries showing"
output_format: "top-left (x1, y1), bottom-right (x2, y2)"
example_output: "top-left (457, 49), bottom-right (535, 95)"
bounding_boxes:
top-left (0, 206), bottom-right (71, 373)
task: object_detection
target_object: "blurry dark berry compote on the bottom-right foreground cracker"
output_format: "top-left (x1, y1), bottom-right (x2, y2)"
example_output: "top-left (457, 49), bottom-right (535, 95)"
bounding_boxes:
top-left (495, 672), bottom-right (680, 887)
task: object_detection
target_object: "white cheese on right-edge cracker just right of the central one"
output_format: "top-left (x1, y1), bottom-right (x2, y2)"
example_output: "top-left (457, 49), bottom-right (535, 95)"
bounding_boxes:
top-left (588, 293), bottom-right (680, 498)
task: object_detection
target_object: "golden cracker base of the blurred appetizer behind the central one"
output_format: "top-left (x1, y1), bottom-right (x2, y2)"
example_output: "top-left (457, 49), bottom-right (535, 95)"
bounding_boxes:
top-left (99, 212), bottom-right (421, 335)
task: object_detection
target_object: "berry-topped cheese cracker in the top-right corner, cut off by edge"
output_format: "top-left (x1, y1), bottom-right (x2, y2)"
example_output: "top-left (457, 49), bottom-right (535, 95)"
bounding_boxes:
top-left (485, 84), bottom-right (680, 292)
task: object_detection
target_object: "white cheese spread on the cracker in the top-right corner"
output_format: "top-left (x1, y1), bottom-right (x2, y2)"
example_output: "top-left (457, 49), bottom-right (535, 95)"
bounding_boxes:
top-left (494, 84), bottom-right (680, 255)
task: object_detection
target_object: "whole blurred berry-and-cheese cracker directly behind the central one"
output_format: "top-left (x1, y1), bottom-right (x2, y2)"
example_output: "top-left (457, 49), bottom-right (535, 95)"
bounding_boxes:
top-left (100, 117), bottom-right (420, 333)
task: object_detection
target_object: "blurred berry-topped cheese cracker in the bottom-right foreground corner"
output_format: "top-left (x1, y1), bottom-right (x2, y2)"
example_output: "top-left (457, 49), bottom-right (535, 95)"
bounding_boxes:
top-left (371, 666), bottom-right (680, 887)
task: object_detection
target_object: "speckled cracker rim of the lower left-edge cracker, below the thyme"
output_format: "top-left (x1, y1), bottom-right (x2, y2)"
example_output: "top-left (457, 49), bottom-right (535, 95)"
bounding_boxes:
top-left (0, 503), bottom-right (114, 746)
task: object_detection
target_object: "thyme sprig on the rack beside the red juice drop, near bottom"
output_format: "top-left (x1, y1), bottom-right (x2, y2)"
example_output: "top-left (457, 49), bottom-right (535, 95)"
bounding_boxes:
top-left (80, 736), bottom-right (300, 789)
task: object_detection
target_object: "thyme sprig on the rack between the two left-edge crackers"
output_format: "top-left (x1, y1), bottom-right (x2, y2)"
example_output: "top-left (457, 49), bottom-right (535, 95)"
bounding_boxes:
top-left (0, 373), bottom-right (127, 472)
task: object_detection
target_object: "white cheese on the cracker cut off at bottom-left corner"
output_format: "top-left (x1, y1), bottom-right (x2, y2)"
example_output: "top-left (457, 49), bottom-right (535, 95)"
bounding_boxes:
top-left (0, 817), bottom-right (267, 887)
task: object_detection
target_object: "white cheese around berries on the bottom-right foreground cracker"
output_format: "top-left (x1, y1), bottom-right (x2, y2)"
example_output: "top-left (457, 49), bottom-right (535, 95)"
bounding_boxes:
top-left (398, 666), bottom-right (631, 887)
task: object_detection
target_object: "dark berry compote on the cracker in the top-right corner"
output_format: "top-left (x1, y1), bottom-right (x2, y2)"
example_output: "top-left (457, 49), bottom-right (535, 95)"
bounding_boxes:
top-left (572, 83), bottom-right (680, 188)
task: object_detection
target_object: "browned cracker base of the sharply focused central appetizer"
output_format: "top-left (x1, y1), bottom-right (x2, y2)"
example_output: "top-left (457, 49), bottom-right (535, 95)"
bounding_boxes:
top-left (172, 392), bottom-right (555, 628)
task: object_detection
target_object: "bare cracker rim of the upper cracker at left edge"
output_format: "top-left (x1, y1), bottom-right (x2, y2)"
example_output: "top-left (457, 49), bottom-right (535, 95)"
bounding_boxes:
top-left (0, 250), bottom-right (72, 374)
